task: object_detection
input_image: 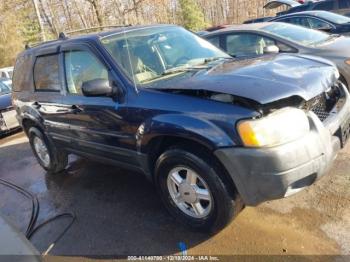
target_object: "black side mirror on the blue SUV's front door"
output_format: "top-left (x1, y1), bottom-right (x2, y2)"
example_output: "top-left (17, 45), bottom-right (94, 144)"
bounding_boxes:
top-left (81, 79), bottom-right (113, 96)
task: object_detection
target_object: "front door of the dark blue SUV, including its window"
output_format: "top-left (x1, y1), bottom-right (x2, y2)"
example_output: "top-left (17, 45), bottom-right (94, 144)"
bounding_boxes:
top-left (54, 45), bottom-right (136, 165)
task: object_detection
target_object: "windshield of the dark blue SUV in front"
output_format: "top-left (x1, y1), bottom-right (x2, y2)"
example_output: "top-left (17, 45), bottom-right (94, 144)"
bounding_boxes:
top-left (101, 26), bottom-right (230, 84)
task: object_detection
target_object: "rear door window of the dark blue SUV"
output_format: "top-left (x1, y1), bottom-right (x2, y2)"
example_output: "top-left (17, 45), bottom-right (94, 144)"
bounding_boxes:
top-left (34, 55), bottom-right (60, 91)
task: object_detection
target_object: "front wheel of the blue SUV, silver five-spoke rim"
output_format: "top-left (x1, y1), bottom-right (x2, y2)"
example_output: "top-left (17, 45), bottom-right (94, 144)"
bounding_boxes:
top-left (155, 148), bottom-right (242, 233)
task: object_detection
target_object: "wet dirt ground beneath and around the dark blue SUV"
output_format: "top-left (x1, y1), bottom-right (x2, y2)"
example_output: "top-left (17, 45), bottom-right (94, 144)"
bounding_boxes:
top-left (0, 132), bottom-right (350, 259)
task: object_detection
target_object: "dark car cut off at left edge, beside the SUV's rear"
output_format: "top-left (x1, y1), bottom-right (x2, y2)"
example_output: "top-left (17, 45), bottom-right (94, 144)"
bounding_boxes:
top-left (0, 81), bottom-right (19, 135)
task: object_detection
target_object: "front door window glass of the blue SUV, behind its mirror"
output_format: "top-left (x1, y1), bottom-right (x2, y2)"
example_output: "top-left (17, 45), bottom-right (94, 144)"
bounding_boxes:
top-left (64, 51), bottom-right (108, 94)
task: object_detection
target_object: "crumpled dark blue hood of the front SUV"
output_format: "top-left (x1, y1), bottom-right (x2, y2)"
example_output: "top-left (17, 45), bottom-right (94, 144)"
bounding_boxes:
top-left (151, 55), bottom-right (339, 104)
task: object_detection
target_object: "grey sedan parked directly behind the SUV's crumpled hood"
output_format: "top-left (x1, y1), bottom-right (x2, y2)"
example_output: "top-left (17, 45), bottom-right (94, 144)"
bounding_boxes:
top-left (203, 22), bottom-right (350, 87)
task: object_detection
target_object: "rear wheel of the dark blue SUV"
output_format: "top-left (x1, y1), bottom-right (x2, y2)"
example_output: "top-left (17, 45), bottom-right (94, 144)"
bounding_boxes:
top-left (28, 127), bottom-right (68, 174)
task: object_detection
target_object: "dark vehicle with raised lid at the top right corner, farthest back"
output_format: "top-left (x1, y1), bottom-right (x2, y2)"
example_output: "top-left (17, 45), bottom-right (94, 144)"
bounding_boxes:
top-left (264, 0), bottom-right (350, 16)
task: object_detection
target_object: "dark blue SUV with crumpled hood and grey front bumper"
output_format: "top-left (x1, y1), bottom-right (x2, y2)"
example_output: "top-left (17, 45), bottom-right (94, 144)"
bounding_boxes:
top-left (13, 25), bottom-right (350, 232)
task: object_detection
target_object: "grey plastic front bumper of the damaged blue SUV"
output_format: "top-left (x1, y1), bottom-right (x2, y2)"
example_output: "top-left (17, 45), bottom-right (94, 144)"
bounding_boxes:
top-left (215, 85), bottom-right (350, 206)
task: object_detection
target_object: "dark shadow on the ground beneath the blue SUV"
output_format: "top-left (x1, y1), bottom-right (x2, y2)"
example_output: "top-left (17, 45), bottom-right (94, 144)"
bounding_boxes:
top-left (41, 158), bottom-right (208, 256)
